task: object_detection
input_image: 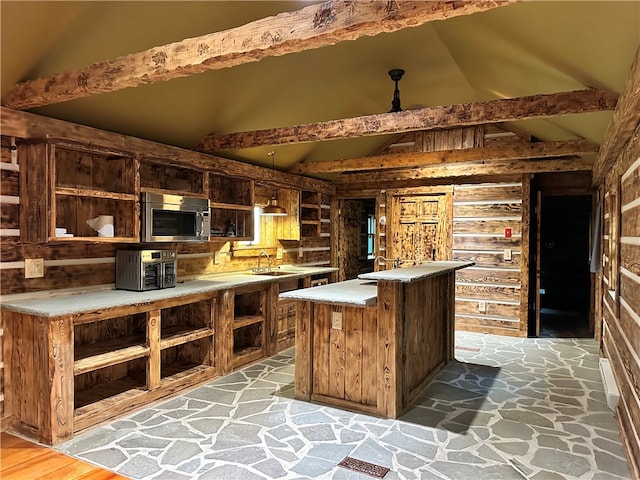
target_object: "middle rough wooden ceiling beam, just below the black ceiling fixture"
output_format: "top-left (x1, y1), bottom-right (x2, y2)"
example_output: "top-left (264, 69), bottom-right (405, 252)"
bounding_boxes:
top-left (198, 89), bottom-right (617, 152)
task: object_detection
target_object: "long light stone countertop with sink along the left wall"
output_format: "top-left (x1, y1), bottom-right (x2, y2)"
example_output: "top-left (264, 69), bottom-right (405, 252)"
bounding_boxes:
top-left (1, 265), bottom-right (337, 317)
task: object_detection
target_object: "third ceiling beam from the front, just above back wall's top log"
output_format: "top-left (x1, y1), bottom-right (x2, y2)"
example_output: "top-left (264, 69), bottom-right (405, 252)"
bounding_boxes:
top-left (289, 139), bottom-right (598, 175)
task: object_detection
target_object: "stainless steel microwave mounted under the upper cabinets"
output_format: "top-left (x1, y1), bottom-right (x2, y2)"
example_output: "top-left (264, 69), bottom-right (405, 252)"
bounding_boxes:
top-left (141, 192), bottom-right (211, 242)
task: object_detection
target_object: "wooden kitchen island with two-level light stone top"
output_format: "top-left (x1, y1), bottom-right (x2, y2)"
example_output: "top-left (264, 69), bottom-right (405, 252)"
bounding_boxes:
top-left (280, 261), bottom-right (473, 418)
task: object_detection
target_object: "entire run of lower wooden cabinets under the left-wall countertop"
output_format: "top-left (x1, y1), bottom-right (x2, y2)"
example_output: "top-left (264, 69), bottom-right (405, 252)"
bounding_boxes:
top-left (2, 276), bottom-right (336, 445)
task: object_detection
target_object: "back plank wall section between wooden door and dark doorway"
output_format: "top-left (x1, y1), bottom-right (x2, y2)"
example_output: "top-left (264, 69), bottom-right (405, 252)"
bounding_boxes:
top-left (453, 177), bottom-right (529, 336)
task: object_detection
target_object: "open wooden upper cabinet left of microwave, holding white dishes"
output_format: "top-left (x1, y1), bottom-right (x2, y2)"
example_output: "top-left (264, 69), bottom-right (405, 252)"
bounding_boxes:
top-left (19, 138), bottom-right (140, 242)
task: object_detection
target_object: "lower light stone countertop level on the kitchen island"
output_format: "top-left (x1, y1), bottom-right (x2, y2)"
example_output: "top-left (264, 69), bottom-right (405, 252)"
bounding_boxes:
top-left (280, 279), bottom-right (378, 307)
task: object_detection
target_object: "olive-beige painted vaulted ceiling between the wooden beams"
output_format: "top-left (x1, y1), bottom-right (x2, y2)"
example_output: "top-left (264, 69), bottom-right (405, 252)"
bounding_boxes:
top-left (0, 0), bottom-right (640, 175)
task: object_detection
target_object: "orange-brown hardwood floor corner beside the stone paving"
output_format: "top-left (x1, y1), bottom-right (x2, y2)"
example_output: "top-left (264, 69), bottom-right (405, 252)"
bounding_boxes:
top-left (0, 432), bottom-right (126, 480)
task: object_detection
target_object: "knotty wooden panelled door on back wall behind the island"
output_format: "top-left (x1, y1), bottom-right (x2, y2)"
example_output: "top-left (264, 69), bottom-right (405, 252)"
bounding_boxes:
top-left (388, 194), bottom-right (451, 263)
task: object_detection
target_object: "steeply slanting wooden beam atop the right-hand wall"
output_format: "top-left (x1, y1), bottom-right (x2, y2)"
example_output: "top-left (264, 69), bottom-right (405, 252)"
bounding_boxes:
top-left (591, 48), bottom-right (640, 185)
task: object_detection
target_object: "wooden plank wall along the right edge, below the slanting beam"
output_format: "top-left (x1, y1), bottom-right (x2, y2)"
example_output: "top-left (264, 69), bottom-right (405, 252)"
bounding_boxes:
top-left (600, 127), bottom-right (640, 478)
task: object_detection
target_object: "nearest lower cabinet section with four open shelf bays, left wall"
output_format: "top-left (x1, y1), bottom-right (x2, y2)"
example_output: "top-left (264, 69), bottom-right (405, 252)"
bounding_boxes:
top-left (3, 292), bottom-right (224, 445)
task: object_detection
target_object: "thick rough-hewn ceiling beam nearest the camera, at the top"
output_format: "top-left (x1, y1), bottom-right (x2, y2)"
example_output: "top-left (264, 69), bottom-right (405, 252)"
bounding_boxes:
top-left (3, 0), bottom-right (515, 110)
